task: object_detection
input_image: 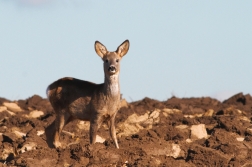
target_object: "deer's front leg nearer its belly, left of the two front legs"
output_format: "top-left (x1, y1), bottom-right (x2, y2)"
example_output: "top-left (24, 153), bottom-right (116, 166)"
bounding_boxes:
top-left (89, 115), bottom-right (103, 144)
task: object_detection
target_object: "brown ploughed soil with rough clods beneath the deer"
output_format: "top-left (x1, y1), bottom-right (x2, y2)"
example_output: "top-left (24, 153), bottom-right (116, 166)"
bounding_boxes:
top-left (0, 93), bottom-right (252, 167)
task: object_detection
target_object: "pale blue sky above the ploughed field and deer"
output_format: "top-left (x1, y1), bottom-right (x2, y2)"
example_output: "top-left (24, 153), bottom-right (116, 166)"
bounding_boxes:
top-left (0, 0), bottom-right (252, 101)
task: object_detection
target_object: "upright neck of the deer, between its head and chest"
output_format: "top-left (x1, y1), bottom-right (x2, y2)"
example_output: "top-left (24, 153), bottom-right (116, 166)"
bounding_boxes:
top-left (104, 74), bottom-right (120, 97)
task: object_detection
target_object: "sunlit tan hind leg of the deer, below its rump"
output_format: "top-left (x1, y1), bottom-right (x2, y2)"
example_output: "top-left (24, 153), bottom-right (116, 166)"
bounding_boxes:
top-left (53, 112), bottom-right (70, 148)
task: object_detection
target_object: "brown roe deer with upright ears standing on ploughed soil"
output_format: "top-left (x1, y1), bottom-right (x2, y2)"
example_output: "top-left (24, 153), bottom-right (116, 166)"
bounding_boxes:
top-left (46, 40), bottom-right (129, 148)
